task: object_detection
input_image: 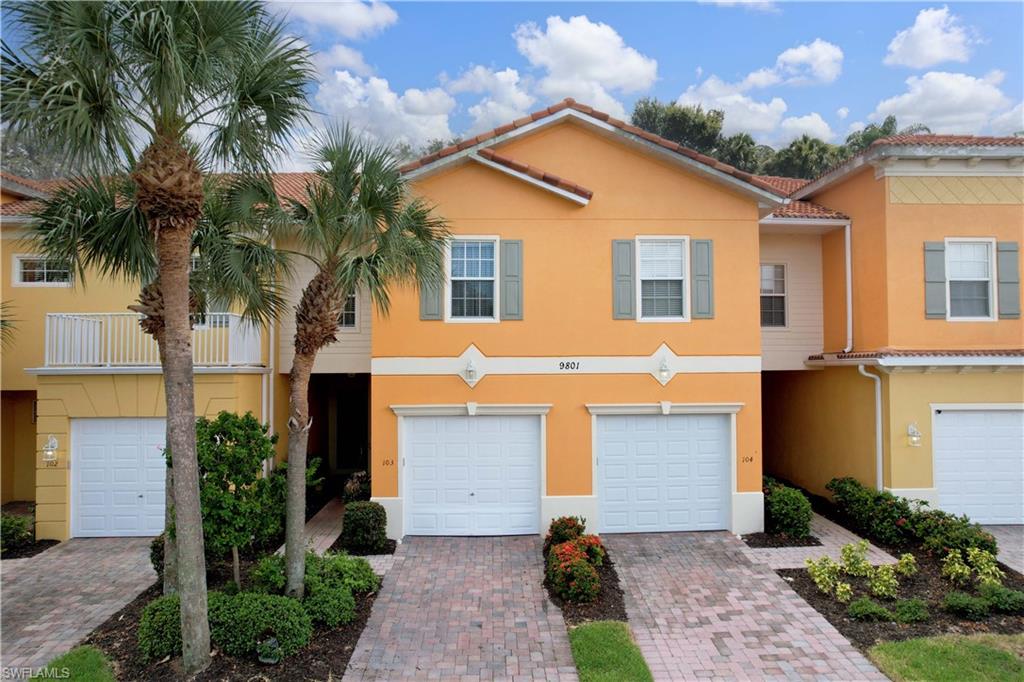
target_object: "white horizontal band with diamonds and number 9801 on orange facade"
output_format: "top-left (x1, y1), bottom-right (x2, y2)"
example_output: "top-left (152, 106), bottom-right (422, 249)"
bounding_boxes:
top-left (370, 343), bottom-right (761, 386)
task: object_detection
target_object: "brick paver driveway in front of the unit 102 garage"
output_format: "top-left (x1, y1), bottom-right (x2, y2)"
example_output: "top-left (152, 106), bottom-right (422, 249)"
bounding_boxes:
top-left (0, 538), bottom-right (157, 667)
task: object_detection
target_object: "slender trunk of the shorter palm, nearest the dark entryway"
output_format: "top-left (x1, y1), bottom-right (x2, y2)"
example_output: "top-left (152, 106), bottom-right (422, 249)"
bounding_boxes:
top-left (285, 352), bottom-right (316, 598)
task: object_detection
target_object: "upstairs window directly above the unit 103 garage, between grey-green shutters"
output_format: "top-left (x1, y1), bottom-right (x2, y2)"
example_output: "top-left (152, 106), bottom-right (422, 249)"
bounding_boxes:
top-left (450, 239), bottom-right (496, 319)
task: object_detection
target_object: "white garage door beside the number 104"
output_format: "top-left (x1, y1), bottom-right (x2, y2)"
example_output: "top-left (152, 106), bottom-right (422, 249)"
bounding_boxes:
top-left (597, 415), bottom-right (731, 532)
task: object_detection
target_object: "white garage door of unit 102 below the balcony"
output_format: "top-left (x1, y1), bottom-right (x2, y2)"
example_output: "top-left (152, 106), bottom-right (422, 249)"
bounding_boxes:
top-left (71, 419), bottom-right (167, 538)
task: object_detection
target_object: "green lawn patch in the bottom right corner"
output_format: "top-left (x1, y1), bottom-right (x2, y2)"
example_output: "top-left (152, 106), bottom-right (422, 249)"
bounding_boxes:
top-left (867, 635), bottom-right (1024, 682)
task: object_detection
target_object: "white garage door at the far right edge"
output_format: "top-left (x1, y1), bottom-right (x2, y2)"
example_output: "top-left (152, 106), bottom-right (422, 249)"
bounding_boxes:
top-left (933, 410), bottom-right (1024, 523)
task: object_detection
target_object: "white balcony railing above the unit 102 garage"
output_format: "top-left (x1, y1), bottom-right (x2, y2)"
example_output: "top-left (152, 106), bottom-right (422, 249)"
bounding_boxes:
top-left (45, 312), bottom-right (262, 368)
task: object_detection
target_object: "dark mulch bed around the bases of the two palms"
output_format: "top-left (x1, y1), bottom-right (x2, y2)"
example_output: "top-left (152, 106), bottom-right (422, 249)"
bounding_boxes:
top-left (83, 560), bottom-right (377, 682)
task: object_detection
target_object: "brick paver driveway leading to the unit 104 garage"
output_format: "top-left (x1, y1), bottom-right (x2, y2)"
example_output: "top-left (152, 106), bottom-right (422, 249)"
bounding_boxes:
top-left (602, 532), bottom-right (886, 681)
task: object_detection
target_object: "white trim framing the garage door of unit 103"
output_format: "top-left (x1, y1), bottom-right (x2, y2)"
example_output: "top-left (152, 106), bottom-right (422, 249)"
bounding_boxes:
top-left (385, 402), bottom-right (551, 539)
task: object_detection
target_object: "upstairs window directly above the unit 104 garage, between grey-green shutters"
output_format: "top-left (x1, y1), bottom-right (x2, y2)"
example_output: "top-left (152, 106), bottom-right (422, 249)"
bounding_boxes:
top-left (637, 239), bottom-right (686, 319)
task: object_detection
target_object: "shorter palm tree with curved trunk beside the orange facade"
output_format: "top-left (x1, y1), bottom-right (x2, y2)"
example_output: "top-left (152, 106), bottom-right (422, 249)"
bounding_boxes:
top-left (260, 127), bottom-right (447, 597)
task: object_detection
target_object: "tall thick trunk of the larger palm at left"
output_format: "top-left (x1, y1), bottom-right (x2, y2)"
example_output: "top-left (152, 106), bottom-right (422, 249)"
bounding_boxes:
top-left (155, 224), bottom-right (210, 676)
